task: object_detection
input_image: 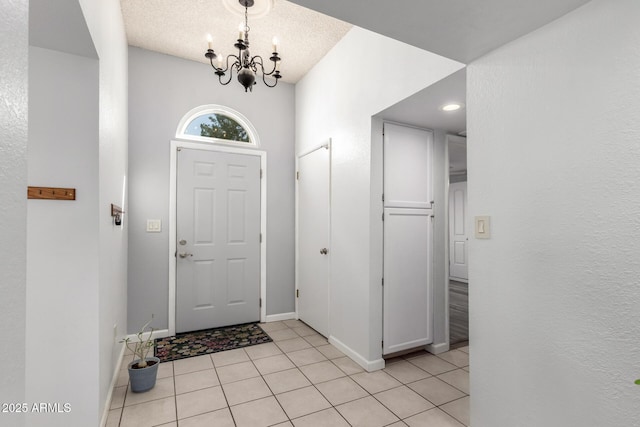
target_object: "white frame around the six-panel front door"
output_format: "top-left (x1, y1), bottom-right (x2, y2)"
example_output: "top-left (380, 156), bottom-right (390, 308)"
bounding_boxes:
top-left (168, 139), bottom-right (267, 336)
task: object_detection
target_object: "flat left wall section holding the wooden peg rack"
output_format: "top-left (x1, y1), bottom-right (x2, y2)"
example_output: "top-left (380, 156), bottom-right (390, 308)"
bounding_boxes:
top-left (26, 47), bottom-right (99, 426)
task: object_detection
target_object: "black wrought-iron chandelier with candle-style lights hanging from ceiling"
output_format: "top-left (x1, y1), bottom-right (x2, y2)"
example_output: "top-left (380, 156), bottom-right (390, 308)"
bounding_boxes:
top-left (204, 0), bottom-right (282, 92)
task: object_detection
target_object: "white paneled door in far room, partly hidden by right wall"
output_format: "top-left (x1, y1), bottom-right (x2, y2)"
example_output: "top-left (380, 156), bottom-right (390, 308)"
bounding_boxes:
top-left (449, 181), bottom-right (469, 282)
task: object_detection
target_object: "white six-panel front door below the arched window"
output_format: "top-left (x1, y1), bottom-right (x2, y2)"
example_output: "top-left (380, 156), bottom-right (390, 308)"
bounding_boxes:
top-left (176, 148), bottom-right (260, 332)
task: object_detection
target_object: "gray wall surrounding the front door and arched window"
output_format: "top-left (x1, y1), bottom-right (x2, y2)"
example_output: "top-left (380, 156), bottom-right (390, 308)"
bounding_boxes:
top-left (126, 47), bottom-right (295, 333)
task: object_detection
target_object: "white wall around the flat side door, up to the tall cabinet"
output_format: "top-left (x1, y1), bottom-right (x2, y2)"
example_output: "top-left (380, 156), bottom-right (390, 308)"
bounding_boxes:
top-left (296, 28), bottom-right (462, 369)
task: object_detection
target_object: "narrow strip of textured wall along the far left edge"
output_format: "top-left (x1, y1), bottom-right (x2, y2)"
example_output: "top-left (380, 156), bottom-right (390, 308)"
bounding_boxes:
top-left (0, 0), bottom-right (29, 426)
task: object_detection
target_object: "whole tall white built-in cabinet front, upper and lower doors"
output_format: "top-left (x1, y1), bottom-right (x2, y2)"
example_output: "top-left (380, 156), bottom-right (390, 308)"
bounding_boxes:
top-left (382, 123), bottom-right (433, 354)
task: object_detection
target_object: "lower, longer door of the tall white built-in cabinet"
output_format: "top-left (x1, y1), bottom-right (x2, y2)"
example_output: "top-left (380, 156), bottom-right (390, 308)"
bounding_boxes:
top-left (382, 208), bottom-right (433, 354)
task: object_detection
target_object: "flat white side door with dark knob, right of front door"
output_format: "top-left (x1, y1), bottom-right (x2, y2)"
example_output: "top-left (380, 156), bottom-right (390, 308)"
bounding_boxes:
top-left (297, 148), bottom-right (330, 337)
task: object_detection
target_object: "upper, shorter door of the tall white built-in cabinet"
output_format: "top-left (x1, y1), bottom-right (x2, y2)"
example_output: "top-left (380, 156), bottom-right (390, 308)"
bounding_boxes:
top-left (384, 123), bottom-right (433, 209)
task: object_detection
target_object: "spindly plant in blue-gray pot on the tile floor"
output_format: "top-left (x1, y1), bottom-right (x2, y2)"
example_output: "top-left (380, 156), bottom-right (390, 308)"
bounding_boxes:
top-left (120, 320), bottom-right (160, 393)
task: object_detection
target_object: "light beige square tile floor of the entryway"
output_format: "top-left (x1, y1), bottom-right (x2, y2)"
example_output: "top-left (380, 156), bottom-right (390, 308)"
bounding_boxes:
top-left (107, 320), bottom-right (469, 427)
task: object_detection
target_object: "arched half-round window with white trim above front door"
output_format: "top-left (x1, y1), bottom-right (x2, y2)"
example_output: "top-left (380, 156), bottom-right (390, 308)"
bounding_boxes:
top-left (176, 105), bottom-right (260, 147)
